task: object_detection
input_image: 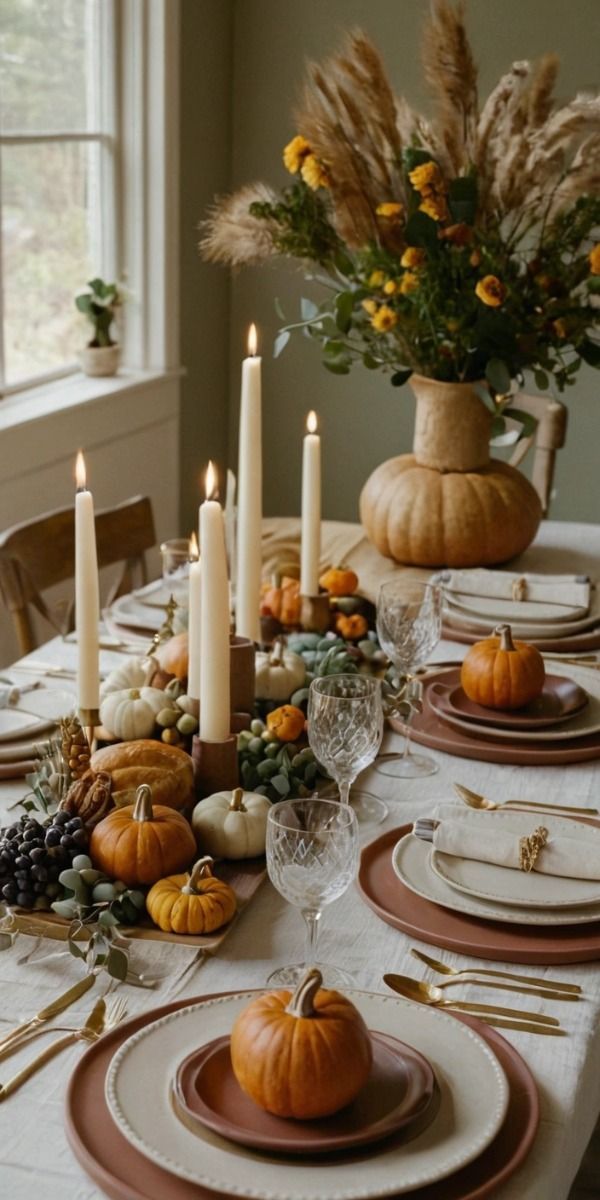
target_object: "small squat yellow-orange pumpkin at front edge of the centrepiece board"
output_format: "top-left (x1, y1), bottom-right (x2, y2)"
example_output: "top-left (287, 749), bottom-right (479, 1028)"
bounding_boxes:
top-left (146, 856), bottom-right (238, 935)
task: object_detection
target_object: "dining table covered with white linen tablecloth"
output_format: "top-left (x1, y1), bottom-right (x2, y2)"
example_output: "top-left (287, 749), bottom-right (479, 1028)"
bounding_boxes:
top-left (0, 518), bottom-right (600, 1200)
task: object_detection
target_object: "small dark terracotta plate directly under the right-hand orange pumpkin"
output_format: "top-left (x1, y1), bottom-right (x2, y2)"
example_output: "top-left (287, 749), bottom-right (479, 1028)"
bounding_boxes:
top-left (440, 670), bottom-right (588, 730)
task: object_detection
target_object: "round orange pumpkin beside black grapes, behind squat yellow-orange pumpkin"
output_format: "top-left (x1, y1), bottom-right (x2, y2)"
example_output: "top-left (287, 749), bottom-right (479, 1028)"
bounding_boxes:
top-left (90, 784), bottom-right (196, 887)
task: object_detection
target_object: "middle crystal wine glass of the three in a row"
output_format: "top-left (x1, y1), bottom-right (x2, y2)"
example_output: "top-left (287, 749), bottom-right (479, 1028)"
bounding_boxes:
top-left (308, 674), bottom-right (388, 823)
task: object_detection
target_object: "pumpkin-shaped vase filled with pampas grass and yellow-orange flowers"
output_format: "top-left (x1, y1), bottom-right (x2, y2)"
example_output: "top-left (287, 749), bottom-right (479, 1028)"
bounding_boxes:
top-left (202, 0), bottom-right (600, 566)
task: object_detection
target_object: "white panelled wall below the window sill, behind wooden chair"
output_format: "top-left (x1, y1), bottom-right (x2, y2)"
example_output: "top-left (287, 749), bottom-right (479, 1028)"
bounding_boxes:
top-left (0, 372), bottom-right (180, 666)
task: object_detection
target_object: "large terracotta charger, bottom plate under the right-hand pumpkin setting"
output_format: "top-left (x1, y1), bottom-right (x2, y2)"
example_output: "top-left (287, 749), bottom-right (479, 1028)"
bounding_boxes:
top-left (389, 671), bottom-right (600, 767)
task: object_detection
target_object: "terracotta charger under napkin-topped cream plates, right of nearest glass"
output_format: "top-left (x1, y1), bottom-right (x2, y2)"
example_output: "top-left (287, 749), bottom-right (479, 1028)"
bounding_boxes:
top-left (356, 821), bottom-right (600, 966)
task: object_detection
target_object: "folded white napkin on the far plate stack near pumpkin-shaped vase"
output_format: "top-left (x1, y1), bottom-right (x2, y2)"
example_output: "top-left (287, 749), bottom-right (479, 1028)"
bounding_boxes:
top-left (443, 568), bottom-right (590, 611)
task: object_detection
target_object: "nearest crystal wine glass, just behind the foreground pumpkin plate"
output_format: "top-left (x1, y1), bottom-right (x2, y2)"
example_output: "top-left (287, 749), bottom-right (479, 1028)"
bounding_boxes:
top-left (266, 799), bottom-right (359, 988)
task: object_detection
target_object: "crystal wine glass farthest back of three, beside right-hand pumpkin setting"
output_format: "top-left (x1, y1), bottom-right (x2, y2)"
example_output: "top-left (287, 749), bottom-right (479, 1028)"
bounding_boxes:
top-left (377, 576), bottom-right (442, 779)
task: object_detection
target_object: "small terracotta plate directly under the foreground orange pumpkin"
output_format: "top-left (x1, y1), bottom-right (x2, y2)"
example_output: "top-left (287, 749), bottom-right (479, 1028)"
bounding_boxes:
top-left (172, 1031), bottom-right (437, 1157)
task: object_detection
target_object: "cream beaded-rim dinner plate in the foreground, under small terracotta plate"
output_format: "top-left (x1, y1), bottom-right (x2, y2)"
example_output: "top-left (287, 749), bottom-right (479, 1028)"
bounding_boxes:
top-left (106, 991), bottom-right (509, 1200)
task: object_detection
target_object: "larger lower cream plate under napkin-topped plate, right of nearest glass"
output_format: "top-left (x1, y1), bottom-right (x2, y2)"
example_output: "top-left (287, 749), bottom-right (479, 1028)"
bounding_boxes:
top-left (391, 835), bottom-right (600, 925)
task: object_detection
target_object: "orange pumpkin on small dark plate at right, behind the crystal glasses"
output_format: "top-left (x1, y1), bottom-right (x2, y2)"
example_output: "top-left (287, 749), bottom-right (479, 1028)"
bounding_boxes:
top-left (461, 625), bottom-right (546, 709)
